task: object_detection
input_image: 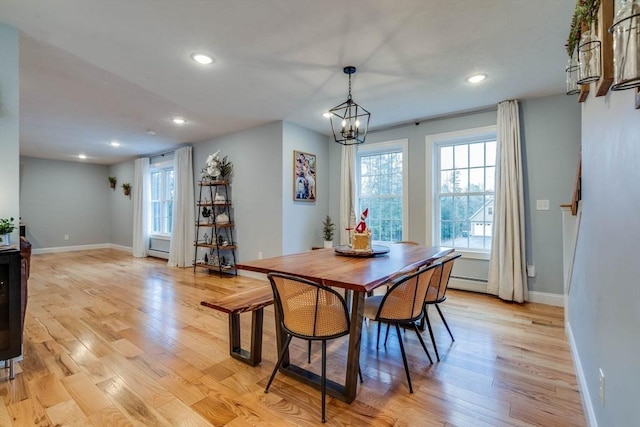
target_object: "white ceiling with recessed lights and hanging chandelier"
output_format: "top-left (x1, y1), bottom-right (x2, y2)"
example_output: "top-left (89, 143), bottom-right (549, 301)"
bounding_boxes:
top-left (0, 0), bottom-right (575, 164)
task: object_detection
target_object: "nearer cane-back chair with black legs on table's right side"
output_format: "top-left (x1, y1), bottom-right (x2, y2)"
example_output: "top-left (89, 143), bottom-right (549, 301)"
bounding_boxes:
top-left (364, 263), bottom-right (440, 393)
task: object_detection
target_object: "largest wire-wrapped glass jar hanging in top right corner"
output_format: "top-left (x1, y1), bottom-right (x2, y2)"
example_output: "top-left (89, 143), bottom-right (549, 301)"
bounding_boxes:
top-left (609, 0), bottom-right (640, 90)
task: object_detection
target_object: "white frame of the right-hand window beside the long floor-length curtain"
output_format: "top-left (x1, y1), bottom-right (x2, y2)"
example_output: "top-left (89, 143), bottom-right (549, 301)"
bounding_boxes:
top-left (425, 125), bottom-right (498, 260)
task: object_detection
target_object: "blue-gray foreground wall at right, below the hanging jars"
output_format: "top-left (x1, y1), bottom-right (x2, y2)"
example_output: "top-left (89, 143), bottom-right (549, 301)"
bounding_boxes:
top-left (567, 90), bottom-right (640, 427)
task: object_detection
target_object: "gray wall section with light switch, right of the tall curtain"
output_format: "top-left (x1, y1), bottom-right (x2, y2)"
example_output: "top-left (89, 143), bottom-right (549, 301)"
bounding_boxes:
top-left (521, 95), bottom-right (580, 293)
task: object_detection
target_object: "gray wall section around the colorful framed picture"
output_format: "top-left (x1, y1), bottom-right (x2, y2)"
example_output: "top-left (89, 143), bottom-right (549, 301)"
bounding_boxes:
top-left (281, 122), bottom-right (330, 254)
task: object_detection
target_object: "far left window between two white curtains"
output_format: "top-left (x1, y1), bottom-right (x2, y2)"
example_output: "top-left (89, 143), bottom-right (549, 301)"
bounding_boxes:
top-left (150, 165), bottom-right (174, 235)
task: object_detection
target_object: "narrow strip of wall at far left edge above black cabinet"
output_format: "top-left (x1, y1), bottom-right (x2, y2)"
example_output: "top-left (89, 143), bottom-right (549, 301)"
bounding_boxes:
top-left (0, 22), bottom-right (20, 242)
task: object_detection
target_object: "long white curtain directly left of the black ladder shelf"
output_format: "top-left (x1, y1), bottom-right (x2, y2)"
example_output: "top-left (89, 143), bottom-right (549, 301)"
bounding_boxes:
top-left (168, 147), bottom-right (195, 267)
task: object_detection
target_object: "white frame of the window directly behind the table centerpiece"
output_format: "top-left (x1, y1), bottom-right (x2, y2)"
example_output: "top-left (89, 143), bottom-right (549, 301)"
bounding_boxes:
top-left (354, 138), bottom-right (409, 243)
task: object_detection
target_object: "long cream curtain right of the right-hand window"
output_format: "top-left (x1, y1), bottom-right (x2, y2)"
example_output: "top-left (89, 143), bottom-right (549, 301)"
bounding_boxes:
top-left (487, 101), bottom-right (529, 302)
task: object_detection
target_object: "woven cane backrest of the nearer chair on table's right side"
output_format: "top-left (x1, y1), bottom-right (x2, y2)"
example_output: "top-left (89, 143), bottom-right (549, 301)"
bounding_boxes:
top-left (376, 264), bottom-right (440, 322)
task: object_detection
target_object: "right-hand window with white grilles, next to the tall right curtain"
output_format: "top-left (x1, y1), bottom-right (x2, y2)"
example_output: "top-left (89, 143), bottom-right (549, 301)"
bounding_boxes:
top-left (433, 127), bottom-right (496, 252)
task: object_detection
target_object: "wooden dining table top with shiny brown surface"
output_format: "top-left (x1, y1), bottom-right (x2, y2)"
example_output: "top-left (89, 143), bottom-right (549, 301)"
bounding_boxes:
top-left (236, 243), bottom-right (453, 292)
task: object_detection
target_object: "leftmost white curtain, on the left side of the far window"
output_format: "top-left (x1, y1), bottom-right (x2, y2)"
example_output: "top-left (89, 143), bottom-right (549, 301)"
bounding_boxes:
top-left (131, 157), bottom-right (151, 258)
